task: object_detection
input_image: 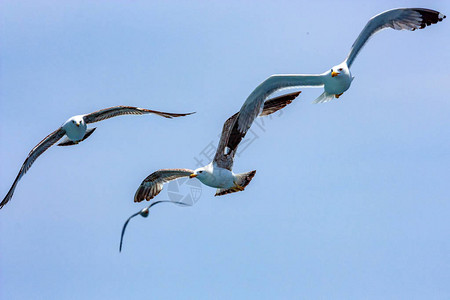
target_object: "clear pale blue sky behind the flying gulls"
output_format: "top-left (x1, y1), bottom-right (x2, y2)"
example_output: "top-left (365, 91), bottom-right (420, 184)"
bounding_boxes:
top-left (0, 0), bottom-right (450, 299)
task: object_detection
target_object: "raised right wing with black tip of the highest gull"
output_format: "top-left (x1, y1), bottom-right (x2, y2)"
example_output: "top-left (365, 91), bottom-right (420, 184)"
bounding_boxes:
top-left (347, 8), bottom-right (445, 67)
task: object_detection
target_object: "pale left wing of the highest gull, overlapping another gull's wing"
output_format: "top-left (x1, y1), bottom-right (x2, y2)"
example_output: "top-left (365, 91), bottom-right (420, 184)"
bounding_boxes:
top-left (237, 74), bottom-right (324, 138)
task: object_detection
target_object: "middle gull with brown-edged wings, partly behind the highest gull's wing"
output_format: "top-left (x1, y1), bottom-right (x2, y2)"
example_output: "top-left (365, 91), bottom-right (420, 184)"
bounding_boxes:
top-left (134, 92), bottom-right (300, 202)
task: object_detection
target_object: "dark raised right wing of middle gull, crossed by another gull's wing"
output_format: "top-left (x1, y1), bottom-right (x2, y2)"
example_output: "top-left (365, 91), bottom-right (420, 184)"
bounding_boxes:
top-left (214, 91), bottom-right (301, 171)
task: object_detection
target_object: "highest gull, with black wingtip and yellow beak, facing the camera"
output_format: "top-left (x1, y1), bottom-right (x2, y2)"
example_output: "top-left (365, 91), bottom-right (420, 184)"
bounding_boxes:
top-left (234, 8), bottom-right (446, 144)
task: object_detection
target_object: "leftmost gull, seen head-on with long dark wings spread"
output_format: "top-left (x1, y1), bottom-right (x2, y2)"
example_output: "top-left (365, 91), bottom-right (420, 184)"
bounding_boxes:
top-left (0, 106), bottom-right (193, 209)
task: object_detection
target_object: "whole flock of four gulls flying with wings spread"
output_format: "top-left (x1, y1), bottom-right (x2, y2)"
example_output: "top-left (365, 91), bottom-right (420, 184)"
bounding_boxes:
top-left (0, 8), bottom-right (445, 251)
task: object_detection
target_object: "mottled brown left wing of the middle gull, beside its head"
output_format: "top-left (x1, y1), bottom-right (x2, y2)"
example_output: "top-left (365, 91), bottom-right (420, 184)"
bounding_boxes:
top-left (134, 169), bottom-right (194, 202)
